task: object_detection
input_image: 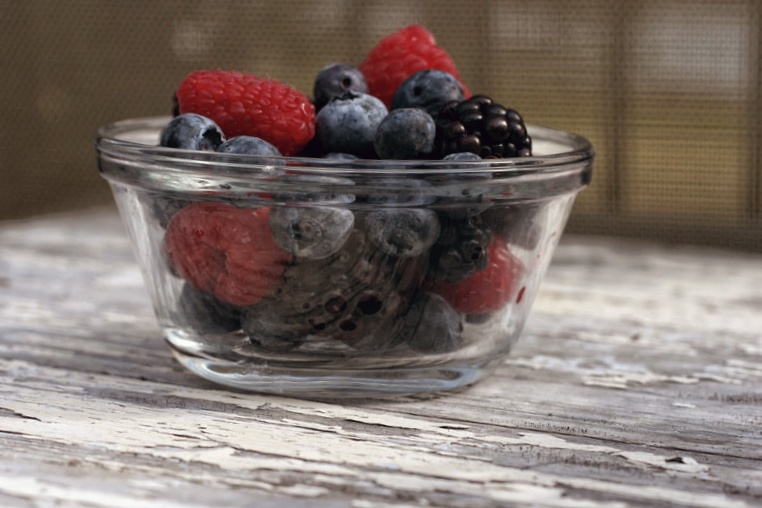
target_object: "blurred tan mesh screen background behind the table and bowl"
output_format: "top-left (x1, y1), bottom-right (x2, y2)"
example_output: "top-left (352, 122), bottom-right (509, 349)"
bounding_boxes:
top-left (0, 0), bottom-right (762, 251)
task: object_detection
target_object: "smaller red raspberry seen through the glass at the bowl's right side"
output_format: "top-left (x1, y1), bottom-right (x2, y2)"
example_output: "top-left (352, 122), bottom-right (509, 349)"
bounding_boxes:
top-left (431, 237), bottom-right (524, 314)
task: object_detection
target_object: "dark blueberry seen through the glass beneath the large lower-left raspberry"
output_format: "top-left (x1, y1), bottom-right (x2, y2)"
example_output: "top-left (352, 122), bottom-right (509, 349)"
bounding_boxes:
top-left (175, 284), bottom-right (241, 333)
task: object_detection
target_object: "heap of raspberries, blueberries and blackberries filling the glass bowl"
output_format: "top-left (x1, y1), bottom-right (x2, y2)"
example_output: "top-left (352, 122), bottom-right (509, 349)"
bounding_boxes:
top-left (158, 26), bottom-right (531, 353)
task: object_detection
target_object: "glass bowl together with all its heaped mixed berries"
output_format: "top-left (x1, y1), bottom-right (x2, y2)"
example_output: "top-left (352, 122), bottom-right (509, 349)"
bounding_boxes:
top-left (96, 26), bottom-right (593, 398)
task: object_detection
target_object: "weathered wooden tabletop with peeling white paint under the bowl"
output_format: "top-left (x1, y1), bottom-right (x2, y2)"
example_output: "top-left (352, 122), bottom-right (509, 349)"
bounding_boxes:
top-left (0, 209), bottom-right (762, 508)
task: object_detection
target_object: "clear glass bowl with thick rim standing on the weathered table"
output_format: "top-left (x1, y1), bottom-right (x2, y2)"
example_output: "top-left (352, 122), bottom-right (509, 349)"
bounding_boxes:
top-left (96, 118), bottom-right (593, 398)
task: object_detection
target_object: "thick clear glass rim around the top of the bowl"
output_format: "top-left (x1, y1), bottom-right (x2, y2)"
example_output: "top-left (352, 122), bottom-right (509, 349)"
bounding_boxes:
top-left (95, 116), bottom-right (595, 177)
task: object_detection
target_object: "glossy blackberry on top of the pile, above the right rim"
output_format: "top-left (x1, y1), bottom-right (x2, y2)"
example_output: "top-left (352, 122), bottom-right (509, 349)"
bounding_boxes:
top-left (434, 95), bottom-right (532, 159)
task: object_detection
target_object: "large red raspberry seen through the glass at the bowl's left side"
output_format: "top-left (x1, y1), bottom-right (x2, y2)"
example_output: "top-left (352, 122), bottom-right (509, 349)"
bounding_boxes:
top-left (164, 202), bottom-right (291, 306)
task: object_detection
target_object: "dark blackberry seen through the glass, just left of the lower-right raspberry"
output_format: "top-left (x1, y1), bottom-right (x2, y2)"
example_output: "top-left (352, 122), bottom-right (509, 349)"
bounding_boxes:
top-left (428, 214), bottom-right (492, 283)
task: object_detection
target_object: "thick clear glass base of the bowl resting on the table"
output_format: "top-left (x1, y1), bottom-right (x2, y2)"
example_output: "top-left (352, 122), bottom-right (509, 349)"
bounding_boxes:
top-left (172, 347), bottom-right (500, 399)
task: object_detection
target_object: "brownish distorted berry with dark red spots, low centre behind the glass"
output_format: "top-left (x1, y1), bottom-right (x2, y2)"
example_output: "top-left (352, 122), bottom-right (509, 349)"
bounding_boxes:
top-left (251, 228), bottom-right (421, 350)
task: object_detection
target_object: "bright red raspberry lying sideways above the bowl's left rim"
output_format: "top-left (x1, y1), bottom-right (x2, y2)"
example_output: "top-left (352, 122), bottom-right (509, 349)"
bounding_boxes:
top-left (175, 70), bottom-right (315, 156)
